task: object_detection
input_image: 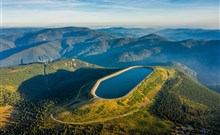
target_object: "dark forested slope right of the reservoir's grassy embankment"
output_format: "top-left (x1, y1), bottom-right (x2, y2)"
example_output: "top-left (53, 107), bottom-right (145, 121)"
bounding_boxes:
top-left (150, 72), bottom-right (220, 133)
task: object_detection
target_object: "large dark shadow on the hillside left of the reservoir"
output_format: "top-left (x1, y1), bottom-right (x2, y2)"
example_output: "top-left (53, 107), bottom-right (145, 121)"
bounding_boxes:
top-left (18, 68), bottom-right (117, 101)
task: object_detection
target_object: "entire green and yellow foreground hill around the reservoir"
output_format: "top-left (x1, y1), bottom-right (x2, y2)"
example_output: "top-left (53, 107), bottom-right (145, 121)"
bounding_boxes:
top-left (0, 59), bottom-right (220, 134)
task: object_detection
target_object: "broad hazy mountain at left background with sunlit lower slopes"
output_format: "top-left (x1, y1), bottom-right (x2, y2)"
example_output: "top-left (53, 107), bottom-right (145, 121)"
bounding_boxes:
top-left (0, 27), bottom-right (115, 67)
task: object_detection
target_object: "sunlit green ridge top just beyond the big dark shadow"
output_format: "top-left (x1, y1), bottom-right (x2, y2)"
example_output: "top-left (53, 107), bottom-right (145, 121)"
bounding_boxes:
top-left (0, 59), bottom-right (95, 91)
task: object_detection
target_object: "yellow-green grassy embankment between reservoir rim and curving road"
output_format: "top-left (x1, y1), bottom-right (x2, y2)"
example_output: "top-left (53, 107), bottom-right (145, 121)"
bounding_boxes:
top-left (52, 68), bottom-right (174, 124)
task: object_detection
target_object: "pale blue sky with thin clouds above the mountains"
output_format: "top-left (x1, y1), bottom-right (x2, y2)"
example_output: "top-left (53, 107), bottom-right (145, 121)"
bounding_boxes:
top-left (0, 0), bottom-right (220, 29)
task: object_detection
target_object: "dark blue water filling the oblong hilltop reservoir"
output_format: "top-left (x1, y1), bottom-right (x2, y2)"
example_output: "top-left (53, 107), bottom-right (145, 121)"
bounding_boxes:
top-left (95, 67), bottom-right (153, 99)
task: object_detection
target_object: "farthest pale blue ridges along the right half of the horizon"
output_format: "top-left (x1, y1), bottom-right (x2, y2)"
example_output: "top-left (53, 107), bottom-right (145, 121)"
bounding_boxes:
top-left (98, 27), bottom-right (220, 40)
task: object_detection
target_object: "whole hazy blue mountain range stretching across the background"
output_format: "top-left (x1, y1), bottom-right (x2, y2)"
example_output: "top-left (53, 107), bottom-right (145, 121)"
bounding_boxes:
top-left (0, 27), bottom-right (220, 91)
